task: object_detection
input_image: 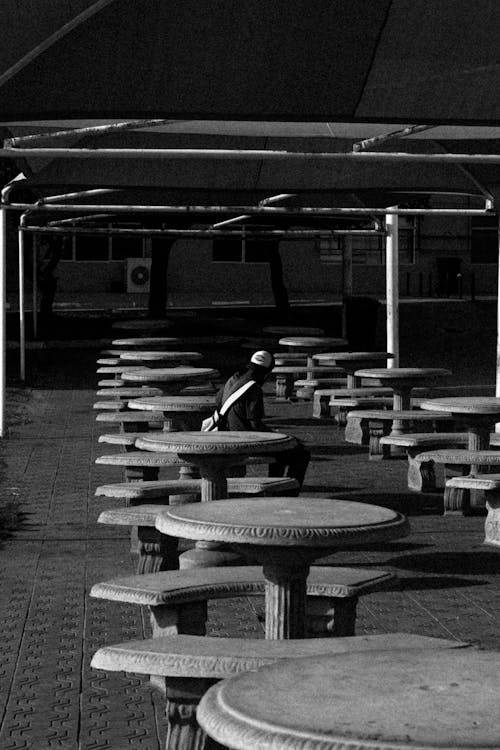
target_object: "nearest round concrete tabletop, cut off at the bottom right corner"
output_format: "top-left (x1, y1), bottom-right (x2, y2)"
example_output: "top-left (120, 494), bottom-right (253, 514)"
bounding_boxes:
top-left (197, 648), bottom-right (500, 750)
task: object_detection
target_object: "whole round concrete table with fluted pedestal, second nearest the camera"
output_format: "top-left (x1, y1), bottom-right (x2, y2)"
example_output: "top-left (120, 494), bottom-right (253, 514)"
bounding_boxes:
top-left (156, 500), bottom-right (409, 639)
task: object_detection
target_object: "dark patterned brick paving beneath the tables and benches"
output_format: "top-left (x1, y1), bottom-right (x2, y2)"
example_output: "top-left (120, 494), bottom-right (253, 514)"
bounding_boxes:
top-left (0, 352), bottom-right (500, 750)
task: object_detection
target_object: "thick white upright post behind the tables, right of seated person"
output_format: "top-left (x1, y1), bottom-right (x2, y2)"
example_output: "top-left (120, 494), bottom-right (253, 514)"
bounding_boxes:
top-left (385, 206), bottom-right (399, 367)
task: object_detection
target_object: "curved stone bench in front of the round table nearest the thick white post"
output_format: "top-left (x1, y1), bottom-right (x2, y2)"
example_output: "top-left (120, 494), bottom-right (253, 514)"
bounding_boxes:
top-left (345, 408), bottom-right (453, 460)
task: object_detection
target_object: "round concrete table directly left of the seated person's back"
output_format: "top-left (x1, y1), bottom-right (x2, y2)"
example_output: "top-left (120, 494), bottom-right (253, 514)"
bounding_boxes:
top-left (128, 395), bottom-right (215, 432)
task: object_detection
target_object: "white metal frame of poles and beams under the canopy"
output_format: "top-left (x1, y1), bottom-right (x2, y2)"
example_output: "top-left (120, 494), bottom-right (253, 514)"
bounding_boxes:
top-left (0, 131), bottom-right (500, 437)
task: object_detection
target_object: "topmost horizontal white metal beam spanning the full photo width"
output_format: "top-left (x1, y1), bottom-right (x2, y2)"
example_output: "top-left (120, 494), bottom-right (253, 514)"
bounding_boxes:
top-left (0, 147), bottom-right (500, 164)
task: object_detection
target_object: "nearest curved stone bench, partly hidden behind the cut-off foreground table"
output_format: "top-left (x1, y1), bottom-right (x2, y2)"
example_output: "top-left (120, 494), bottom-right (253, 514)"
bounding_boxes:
top-left (91, 633), bottom-right (464, 750)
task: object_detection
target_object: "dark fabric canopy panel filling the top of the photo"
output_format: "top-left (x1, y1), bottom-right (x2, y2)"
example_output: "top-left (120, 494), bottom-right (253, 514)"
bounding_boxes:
top-left (0, 0), bottom-right (500, 124)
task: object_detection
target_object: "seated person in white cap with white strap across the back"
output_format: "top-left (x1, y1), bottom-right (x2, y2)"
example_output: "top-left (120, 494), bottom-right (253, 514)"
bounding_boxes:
top-left (215, 351), bottom-right (311, 494)
